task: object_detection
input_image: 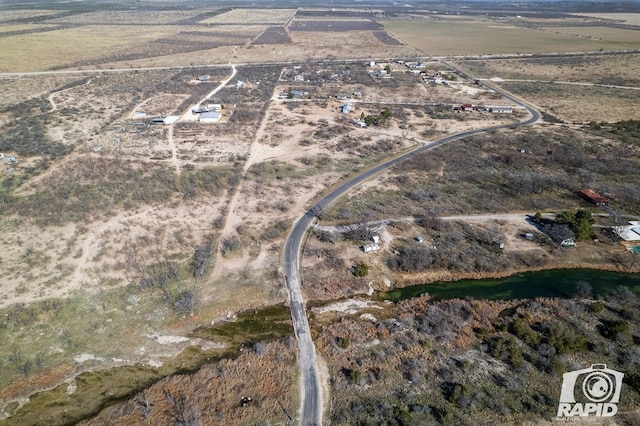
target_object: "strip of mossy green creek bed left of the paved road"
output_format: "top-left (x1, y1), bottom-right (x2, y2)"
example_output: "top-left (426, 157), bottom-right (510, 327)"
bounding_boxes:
top-left (4, 305), bottom-right (293, 426)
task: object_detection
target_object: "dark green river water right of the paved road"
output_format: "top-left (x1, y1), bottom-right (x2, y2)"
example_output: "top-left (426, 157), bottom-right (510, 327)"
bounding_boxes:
top-left (378, 269), bottom-right (640, 302)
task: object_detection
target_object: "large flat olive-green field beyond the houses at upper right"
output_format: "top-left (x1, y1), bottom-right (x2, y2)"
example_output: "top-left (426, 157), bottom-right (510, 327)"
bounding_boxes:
top-left (381, 21), bottom-right (640, 55)
